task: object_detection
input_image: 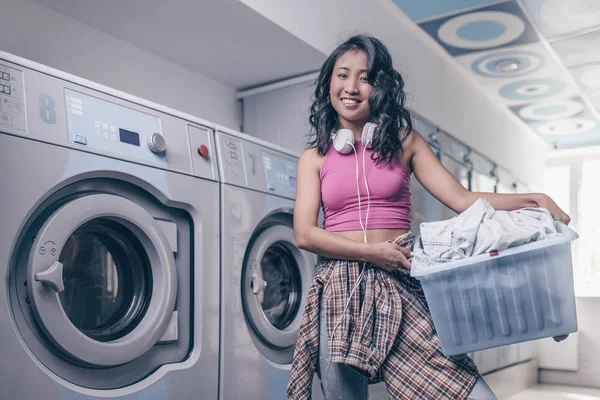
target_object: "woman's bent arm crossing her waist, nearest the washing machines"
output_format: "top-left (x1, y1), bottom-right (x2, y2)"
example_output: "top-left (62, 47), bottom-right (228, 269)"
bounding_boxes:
top-left (294, 149), bottom-right (410, 269)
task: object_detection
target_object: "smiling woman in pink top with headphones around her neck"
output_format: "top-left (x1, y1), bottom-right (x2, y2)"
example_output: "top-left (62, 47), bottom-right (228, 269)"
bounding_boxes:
top-left (288, 36), bottom-right (569, 400)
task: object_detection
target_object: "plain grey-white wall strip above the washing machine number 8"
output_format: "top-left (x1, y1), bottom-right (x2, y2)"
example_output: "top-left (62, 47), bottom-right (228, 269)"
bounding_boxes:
top-left (0, 0), bottom-right (241, 130)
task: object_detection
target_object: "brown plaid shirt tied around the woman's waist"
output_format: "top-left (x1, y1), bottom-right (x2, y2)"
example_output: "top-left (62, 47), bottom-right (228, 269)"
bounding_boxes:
top-left (287, 233), bottom-right (477, 400)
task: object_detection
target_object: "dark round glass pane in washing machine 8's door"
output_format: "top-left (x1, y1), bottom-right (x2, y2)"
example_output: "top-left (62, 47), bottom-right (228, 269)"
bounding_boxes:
top-left (58, 219), bottom-right (152, 342)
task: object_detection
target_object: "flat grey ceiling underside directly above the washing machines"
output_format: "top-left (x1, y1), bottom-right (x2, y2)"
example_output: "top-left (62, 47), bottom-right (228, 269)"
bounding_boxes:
top-left (33, 0), bottom-right (325, 89)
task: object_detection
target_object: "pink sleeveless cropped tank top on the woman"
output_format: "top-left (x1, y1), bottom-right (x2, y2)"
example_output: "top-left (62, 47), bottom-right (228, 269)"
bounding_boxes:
top-left (320, 142), bottom-right (411, 232)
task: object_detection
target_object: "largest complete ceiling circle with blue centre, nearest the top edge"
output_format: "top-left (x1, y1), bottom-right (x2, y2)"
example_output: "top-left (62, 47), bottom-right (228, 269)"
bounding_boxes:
top-left (438, 11), bottom-right (525, 49)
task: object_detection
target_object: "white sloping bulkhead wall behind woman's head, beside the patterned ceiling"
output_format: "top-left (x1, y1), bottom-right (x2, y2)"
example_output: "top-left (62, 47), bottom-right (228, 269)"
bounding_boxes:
top-left (240, 0), bottom-right (544, 189)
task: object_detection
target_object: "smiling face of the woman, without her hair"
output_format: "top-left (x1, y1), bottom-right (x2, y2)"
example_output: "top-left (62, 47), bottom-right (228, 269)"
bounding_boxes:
top-left (329, 50), bottom-right (374, 129)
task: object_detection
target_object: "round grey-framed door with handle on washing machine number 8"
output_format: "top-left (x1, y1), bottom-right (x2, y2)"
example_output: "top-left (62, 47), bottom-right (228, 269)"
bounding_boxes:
top-left (28, 194), bottom-right (177, 366)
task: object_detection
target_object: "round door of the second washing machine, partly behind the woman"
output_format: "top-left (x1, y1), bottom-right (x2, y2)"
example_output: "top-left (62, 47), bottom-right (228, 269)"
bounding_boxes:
top-left (242, 225), bottom-right (315, 349)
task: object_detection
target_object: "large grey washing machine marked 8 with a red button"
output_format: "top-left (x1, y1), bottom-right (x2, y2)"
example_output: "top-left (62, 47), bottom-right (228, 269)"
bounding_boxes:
top-left (0, 53), bottom-right (219, 400)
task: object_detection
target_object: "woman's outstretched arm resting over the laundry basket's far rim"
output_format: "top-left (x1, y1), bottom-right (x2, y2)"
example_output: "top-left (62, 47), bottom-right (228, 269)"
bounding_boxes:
top-left (407, 130), bottom-right (571, 224)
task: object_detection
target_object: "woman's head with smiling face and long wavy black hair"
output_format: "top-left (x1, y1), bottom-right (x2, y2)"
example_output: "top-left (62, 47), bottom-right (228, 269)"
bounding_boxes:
top-left (308, 37), bottom-right (412, 169)
